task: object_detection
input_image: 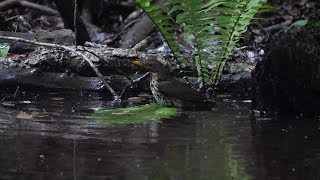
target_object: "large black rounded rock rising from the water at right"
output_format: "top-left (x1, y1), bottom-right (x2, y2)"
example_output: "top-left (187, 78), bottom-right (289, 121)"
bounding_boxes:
top-left (252, 15), bottom-right (320, 116)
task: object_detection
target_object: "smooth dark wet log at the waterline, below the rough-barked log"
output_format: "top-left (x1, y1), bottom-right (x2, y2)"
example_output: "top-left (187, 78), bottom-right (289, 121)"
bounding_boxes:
top-left (0, 68), bottom-right (148, 94)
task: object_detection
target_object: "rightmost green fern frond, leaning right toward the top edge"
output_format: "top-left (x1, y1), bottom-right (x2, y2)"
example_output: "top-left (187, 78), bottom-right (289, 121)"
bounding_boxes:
top-left (210, 0), bottom-right (266, 85)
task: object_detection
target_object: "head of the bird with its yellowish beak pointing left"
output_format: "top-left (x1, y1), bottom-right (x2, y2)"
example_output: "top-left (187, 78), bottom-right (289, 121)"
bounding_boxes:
top-left (132, 60), bottom-right (170, 74)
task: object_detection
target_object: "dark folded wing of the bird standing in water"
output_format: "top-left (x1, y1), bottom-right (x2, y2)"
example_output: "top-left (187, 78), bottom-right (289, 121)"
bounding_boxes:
top-left (158, 80), bottom-right (205, 102)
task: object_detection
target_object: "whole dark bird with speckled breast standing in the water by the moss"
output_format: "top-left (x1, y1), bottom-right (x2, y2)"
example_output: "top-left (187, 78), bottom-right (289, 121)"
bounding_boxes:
top-left (132, 59), bottom-right (213, 109)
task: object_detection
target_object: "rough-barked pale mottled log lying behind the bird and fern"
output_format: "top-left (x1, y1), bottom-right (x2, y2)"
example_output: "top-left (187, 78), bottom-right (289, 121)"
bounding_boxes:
top-left (0, 41), bottom-right (255, 76)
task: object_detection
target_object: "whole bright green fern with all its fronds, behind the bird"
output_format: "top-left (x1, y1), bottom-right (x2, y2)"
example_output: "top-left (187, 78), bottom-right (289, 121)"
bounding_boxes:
top-left (136, 0), bottom-right (269, 86)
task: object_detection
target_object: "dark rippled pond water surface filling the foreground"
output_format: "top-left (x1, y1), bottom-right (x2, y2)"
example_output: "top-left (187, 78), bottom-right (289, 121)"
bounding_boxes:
top-left (0, 89), bottom-right (320, 180)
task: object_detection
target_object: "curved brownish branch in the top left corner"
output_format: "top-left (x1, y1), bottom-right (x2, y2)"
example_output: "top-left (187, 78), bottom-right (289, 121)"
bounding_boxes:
top-left (0, 0), bottom-right (59, 15)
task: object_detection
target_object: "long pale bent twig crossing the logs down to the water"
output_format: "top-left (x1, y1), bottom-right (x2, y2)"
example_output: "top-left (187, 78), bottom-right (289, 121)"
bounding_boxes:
top-left (0, 36), bottom-right (120, 100)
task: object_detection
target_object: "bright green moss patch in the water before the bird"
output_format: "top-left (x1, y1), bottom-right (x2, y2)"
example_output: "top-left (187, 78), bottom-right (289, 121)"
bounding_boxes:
top-left (92, 103), bottom-right (179, 124)
